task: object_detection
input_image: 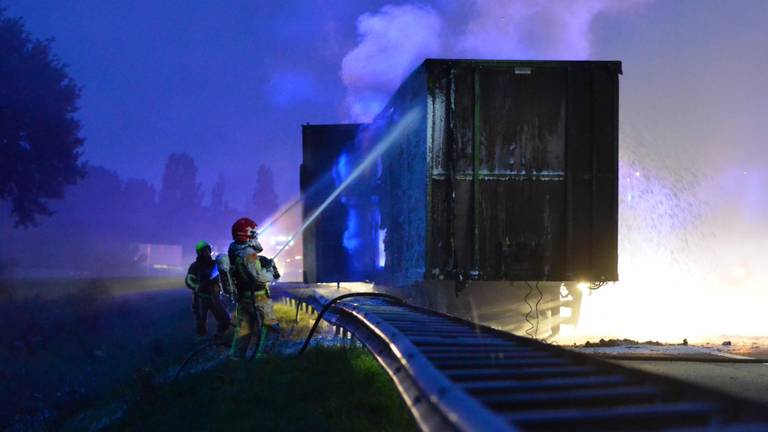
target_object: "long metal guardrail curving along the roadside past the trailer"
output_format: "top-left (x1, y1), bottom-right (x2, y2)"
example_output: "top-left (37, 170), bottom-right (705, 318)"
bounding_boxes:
top-left (284, 297), bottom-right (768, 431)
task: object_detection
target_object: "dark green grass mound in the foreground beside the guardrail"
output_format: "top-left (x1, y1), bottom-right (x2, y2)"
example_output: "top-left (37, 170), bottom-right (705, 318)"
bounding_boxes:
top-left (108, 347), bottom-right (417, 432)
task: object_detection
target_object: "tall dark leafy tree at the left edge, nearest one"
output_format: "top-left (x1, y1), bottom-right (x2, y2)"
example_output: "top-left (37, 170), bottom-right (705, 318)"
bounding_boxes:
top-left (0, 8), bottom-right (85, 226)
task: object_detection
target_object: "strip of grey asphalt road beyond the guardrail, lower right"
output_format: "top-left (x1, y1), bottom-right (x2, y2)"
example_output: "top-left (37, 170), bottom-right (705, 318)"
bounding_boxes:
top-left (615, 360), bottom-right (768, 404)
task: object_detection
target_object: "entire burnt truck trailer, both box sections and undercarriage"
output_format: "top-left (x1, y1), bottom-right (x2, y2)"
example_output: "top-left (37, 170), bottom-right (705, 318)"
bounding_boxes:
top-left (302, 59), bottom-right (621, 337)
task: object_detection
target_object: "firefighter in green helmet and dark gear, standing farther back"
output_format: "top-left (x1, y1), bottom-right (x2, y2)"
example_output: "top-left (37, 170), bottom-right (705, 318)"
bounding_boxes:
top-left (185, 241), bottom-right (230, 337)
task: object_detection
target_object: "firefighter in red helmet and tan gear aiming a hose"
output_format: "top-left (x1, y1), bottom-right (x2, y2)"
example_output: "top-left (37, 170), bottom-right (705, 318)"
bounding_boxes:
top-left (228, 218), bottom-right (280, 358)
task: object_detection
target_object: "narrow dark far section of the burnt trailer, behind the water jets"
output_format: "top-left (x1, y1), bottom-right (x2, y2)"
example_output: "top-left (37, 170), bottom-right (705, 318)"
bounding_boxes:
top-left (299, 124), bottom-right (361, 283)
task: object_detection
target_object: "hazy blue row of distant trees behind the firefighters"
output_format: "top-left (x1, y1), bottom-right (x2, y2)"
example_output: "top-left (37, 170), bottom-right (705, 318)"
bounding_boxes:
top-left (0, 153), bottom-right (277, 275)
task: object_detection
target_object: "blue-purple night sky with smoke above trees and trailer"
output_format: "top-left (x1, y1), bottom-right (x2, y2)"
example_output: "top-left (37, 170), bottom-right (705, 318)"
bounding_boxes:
top-left (1, 0), bottom-right (768, 207)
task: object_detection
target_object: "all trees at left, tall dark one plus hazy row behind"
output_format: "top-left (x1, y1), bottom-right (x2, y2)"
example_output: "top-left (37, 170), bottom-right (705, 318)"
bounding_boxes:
top-left (0, 10), bottom-right (277, 274)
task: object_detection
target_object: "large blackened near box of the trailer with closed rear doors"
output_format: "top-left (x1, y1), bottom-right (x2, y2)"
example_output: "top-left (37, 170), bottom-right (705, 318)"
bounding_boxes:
top-left (376, 60), bottom-right (621, 286)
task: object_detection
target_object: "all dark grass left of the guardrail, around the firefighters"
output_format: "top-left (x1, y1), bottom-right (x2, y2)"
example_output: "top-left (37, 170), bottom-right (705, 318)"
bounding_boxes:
top-left (0, 279), bottom-right (413, 430)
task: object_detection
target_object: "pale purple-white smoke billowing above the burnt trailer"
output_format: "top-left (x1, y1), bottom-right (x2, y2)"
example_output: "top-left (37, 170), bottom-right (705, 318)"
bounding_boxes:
top-left (341, 0), bottom-right (648, 121)
